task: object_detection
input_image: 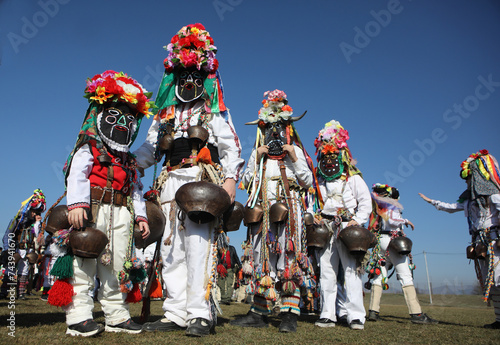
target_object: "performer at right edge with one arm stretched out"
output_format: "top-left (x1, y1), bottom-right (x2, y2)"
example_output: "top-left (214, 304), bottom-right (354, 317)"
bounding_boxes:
top-left (419, 150), bottom-right (500, 329)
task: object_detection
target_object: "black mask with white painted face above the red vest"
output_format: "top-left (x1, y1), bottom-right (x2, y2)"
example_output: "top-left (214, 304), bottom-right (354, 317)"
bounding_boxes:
top-left (97, 103), bottom-right (137, 152)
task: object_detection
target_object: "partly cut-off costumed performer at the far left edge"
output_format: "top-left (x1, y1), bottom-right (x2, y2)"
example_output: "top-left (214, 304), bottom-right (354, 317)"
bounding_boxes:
top-left (0, 189), bottom-right (46, 299)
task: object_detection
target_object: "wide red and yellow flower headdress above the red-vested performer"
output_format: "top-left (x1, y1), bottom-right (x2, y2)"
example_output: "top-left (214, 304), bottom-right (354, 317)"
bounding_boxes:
top-left (84, 70), bottom-right (154, 117)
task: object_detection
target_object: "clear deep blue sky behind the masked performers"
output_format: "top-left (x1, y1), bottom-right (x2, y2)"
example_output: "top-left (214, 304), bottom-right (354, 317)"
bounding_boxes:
top-left (0, 0), bottom-right (500, 289)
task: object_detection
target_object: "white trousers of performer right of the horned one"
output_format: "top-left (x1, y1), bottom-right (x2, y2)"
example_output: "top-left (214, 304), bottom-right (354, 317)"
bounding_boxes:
top-left (320, 232), bottom-right (366, 324)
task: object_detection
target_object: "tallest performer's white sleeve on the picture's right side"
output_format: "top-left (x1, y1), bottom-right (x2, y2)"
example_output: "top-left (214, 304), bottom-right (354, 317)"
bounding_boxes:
top-left (209, 112), bottom-right (245, 181)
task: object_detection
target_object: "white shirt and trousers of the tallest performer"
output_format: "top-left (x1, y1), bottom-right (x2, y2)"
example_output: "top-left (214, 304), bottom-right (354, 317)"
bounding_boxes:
top-left (134, 101), bottom-right (244, 327)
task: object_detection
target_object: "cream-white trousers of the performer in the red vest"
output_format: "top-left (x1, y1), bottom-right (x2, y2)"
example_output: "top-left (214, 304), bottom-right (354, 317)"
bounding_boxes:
top-left (65, 204), bottom-right (130, 326)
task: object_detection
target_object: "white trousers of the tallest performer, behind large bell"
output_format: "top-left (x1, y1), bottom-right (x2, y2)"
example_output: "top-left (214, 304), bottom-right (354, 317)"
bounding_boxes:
top-left (161, 166), bottom-right (216, 327)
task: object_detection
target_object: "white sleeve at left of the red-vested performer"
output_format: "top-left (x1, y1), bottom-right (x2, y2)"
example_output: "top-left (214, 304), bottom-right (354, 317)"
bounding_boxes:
top-left (66, 144), bottom-right (94, 210)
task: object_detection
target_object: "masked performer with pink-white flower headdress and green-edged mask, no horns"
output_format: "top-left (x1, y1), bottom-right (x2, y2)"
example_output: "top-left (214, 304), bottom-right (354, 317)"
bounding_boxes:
top-left (312, 120), bottom-right (372, 329)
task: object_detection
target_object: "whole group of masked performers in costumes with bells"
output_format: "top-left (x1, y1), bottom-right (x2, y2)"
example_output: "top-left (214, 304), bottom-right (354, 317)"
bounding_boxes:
top-left (0, 24), bottom-right (500, 337)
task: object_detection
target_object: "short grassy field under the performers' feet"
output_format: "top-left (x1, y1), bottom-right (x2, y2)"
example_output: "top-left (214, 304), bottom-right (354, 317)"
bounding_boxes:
top-left (0, 294), bottom-right (500, 345)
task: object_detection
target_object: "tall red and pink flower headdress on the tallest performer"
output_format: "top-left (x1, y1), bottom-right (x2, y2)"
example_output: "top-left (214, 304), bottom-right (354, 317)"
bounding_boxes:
top-left (163, 23), bottom-right (219, 73)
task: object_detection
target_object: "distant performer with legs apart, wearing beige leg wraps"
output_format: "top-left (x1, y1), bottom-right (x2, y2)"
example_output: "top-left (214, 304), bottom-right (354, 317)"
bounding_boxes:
top-left (367, 183), bottom-right (437, 324)
